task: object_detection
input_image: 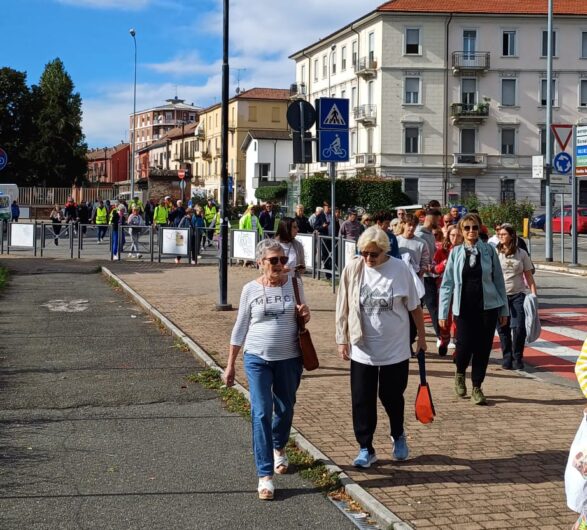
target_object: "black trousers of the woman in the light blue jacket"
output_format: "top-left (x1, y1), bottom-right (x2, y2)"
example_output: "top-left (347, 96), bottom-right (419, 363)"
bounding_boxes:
top-left (455, 309), bottom-right (498, 387)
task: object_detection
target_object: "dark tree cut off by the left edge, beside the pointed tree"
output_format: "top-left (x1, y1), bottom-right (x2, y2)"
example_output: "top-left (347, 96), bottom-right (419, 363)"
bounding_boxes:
top-left (0, 68), bottom-right (34, 185)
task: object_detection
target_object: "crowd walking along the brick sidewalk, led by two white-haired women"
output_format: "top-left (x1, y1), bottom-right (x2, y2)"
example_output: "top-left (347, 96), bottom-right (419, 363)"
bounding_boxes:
top-left (223, 196), bottom-right (537, 499)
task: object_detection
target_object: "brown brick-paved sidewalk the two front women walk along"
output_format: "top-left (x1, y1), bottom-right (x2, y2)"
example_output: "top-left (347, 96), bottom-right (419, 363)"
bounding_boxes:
top-left (96, 264), bottom-right (585, 530)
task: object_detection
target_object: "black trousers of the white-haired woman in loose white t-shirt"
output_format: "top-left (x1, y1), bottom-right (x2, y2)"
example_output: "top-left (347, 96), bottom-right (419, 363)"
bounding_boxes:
top-left (351, 359), bottom-right (410, 453)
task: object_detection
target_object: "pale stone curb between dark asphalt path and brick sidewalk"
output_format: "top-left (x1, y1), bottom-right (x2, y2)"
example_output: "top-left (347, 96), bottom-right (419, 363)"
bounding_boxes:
top-left (102, 266), bottom-right (413, 530)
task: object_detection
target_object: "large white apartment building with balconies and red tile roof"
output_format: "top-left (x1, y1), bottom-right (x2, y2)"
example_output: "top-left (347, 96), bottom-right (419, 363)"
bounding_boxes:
top-left (291, 0), bottom-right (587, 204)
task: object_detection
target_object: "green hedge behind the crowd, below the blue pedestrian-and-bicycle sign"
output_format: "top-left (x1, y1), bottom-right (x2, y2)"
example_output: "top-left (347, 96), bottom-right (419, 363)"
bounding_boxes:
top-left (300, 175), bottom-right (412, 212)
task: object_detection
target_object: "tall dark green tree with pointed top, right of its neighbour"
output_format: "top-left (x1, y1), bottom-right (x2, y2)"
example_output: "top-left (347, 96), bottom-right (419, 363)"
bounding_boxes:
top-left (33, 59), bottom-right (87, 187)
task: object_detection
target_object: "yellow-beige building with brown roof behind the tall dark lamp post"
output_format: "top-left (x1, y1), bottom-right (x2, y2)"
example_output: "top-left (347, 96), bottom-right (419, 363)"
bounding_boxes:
top-left (192, 88), bottom-right (289, 202)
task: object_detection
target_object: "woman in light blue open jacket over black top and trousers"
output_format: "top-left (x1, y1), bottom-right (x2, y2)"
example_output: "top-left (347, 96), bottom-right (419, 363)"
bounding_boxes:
top-left (438, 214), bottom-right (509, 405)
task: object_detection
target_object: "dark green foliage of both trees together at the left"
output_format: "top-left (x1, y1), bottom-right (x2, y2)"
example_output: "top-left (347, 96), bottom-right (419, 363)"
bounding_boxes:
top-left (0, 59), bottom-right (87, 187)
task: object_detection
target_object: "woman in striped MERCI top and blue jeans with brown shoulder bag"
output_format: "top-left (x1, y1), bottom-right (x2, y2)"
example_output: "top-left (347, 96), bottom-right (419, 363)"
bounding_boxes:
top-left (223, 239), bottom-right (310, 500)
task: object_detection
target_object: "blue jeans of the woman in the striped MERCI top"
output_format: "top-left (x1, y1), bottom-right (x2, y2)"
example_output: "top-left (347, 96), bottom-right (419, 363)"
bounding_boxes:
top-left (244, 352), bottom-right (302, 477)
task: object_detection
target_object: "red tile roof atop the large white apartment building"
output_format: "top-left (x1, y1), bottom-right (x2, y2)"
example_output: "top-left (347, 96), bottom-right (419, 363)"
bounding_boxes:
top-left (377, 0), bottom-right (587, 16)
